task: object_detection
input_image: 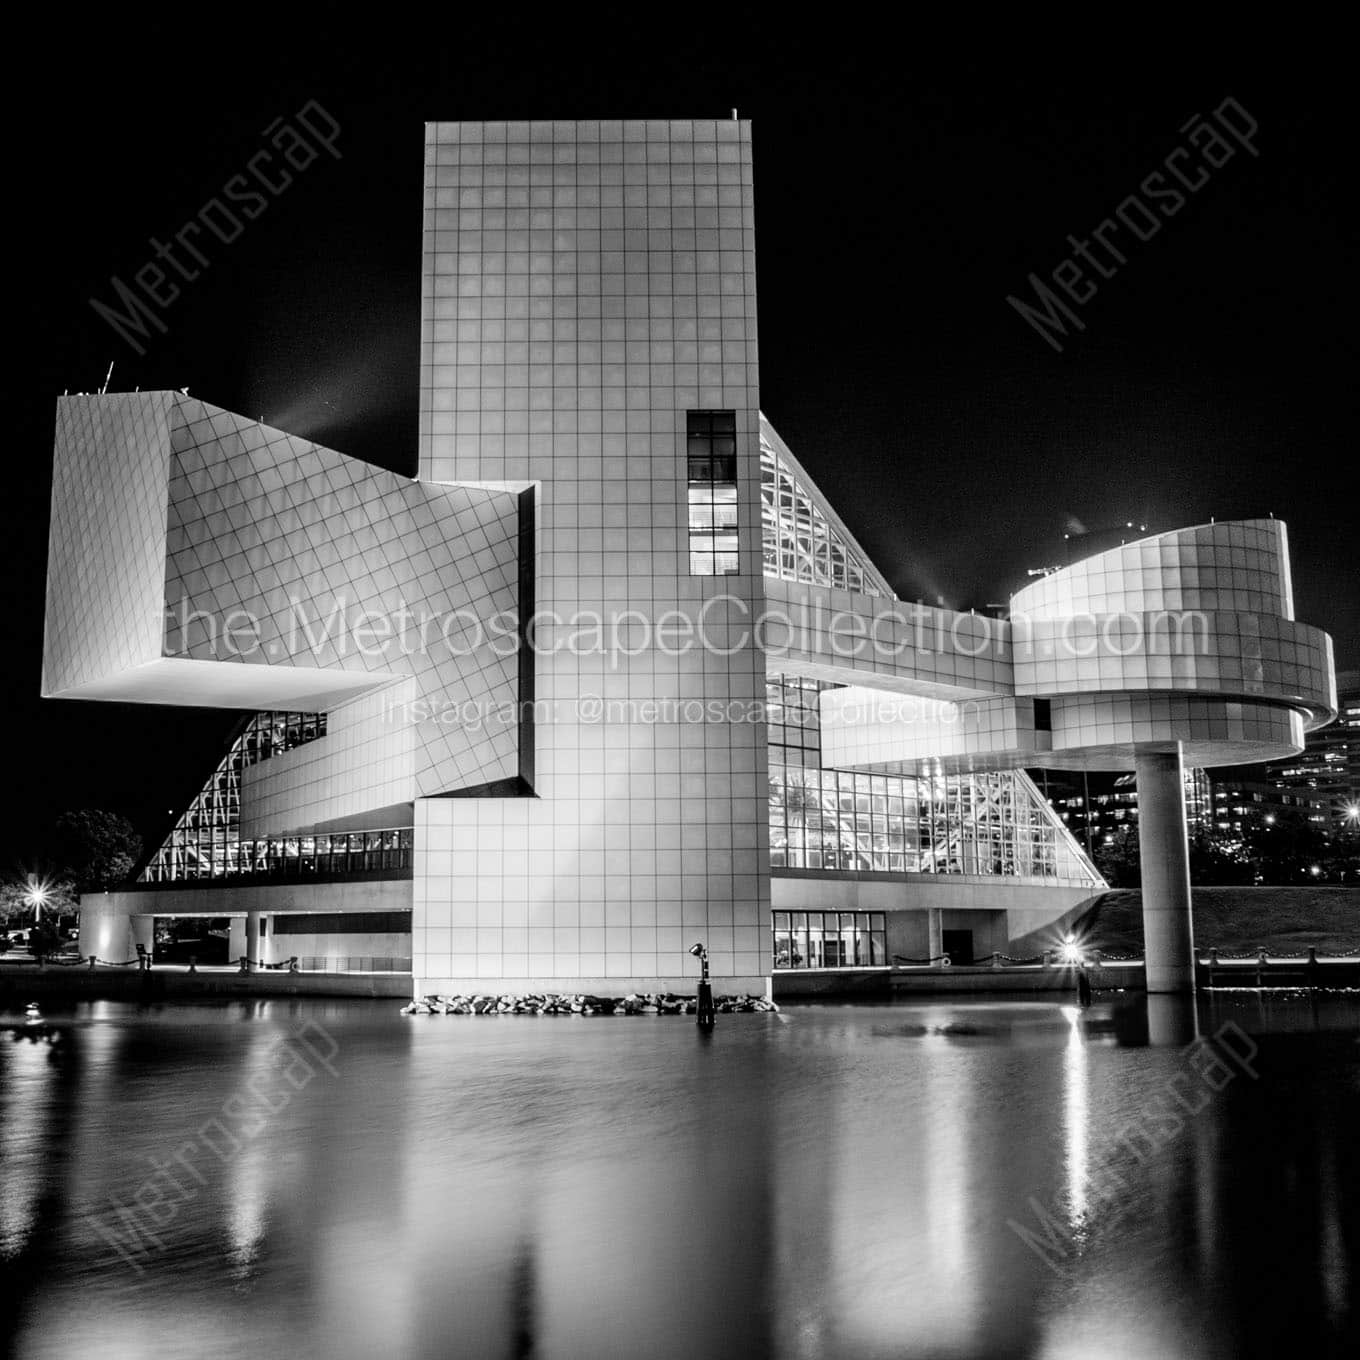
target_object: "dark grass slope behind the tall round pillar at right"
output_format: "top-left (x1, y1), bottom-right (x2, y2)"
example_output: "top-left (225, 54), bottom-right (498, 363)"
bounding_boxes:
top-left (1077, 888), bottom-right (1360, 953)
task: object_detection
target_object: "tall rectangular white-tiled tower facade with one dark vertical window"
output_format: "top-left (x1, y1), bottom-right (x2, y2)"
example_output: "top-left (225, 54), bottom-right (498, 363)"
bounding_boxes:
top-left (412, 120), bottom-right (770, 994)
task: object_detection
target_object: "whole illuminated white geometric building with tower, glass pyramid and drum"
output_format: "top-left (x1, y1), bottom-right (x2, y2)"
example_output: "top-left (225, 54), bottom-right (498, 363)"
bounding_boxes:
top-left (44, 120), bottom-right (1336, 994)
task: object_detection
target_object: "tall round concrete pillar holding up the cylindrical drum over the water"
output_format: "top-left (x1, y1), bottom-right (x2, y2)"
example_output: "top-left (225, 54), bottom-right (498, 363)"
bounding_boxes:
top-left (1134, 743), bottom-right (1194, 993)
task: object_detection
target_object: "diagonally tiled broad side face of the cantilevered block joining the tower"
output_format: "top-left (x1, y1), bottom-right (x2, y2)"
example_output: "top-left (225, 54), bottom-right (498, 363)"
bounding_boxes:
top-left (165, 397), bottom-right (520, 794)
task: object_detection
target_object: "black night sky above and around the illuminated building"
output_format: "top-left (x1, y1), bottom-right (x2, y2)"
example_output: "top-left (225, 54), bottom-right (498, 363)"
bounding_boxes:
top-left (0, 23), bottom-right (1360, 868)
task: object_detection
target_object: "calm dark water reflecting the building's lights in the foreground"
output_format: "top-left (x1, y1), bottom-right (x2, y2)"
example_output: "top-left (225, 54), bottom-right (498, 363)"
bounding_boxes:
top-left (0, 996), bottom-right (1360, 1360)
